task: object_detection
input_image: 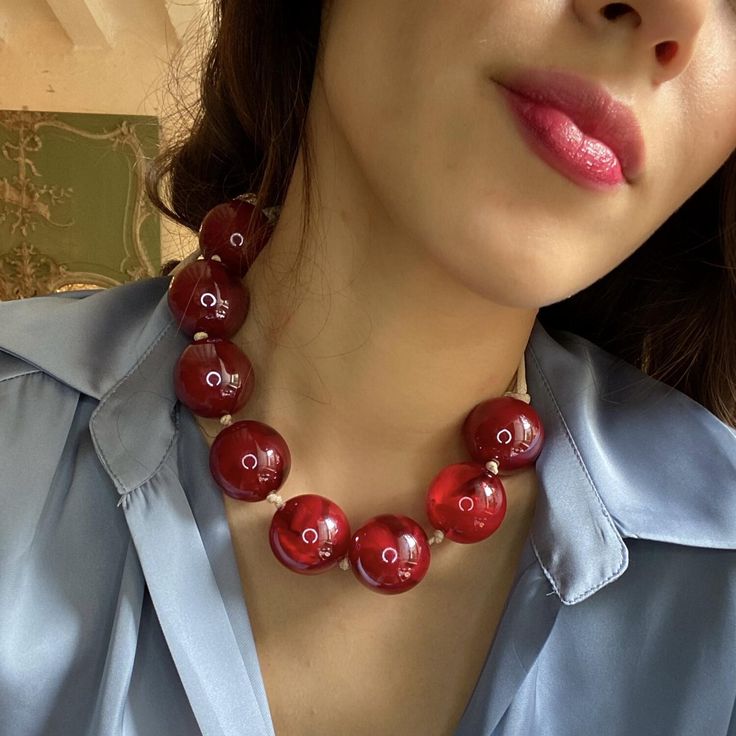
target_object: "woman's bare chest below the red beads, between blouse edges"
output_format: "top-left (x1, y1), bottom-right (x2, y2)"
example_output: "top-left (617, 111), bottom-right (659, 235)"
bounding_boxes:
top-left (225, 478), bottom-right (535, 736)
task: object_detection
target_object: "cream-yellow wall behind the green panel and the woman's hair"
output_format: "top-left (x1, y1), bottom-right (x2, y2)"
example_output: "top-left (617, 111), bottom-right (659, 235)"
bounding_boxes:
top-left (0, 0), bottom-right (209, 260)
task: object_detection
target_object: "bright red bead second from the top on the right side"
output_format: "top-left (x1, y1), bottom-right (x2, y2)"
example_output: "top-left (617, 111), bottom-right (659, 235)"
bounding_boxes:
top-left (427, 463), bottom-right (506, 544)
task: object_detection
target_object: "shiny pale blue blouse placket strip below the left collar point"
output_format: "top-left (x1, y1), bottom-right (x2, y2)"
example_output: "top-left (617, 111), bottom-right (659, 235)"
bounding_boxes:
top-left (122, 455), bottom-right (271, 736)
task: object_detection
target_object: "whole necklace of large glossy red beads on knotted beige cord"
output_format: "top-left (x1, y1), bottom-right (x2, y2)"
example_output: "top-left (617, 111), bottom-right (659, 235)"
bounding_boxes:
top-left (168, 199), bottom-right (544, 593)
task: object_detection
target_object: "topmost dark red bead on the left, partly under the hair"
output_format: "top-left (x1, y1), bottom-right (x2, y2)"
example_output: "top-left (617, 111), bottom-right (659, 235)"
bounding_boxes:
top-left (199, 199), bottom-right (272, 278)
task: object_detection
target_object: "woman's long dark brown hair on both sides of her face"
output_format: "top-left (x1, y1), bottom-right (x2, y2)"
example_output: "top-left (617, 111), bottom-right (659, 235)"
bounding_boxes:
top-left (147, 0), bottom-right (736, 426)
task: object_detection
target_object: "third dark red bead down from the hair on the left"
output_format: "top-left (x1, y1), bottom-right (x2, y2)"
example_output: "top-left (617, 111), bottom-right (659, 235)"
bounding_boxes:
top-left (174, 339), bottom-right (255, 417)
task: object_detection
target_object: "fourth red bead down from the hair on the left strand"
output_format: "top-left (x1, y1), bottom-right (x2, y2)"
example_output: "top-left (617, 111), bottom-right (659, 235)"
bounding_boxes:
top-left (210, 419), bottom-right (291, 501)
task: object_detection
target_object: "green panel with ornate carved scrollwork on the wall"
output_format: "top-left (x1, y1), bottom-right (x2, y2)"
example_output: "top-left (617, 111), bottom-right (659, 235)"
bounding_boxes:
top-left (0, 110), bottom-right (161, 300)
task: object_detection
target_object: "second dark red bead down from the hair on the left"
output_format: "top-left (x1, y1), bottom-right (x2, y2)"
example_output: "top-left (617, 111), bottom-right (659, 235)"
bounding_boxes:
top-left (168, 260), bottom-right (250, 338)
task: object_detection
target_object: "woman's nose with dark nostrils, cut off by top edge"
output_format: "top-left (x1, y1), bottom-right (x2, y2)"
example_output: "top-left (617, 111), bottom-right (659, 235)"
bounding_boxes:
top-left (572, 0), bottom-right (711, 84)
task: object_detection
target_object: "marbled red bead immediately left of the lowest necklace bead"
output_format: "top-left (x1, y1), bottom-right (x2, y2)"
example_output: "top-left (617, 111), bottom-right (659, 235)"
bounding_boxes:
top-left (269, 493), bottom-right (350, 575)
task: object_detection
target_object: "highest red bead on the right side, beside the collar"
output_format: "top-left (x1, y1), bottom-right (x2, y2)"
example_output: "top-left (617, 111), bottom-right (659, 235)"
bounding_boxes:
top-left (462, 396), bottom-right (544, 472)
